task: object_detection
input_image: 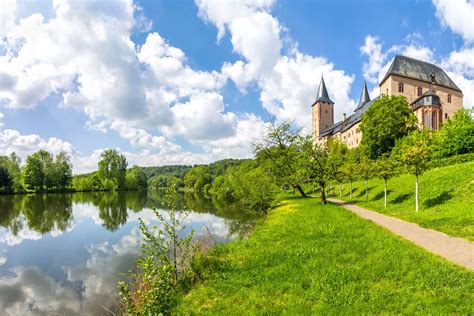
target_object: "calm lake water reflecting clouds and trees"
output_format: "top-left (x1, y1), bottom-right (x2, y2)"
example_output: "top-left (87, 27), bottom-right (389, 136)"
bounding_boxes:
top-left (0, 191), bottom-right (253, 315)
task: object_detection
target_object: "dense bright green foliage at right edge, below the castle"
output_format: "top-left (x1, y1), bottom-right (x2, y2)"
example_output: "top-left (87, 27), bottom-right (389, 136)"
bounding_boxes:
top-left (433, 109), bottom-right (474, 158)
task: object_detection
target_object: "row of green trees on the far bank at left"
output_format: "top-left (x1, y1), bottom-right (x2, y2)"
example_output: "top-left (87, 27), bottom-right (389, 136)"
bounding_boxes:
top-left (0, 149), bottom-right (148, 193)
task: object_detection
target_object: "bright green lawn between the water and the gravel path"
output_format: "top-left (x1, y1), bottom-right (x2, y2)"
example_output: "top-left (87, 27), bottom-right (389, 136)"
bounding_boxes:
top-left (177, 199), bottom-right (474, 314)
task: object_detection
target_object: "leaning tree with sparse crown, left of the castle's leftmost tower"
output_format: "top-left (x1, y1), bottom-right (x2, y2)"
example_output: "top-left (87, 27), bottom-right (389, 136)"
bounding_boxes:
top-left (253, 120), bottom-right (307, 197)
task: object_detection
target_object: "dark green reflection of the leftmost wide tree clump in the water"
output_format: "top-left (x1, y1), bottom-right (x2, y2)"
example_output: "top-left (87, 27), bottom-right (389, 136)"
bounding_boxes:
top-left (20, 194), bottom-right (72, 234)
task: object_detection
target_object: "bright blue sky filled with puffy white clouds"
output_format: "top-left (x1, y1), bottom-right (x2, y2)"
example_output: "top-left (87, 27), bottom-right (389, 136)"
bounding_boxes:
top-left (0, 0), bottom-right (474, 172)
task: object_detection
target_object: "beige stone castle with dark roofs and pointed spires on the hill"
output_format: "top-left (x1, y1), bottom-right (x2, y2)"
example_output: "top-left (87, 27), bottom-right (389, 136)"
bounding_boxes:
top-left (311, 55), bottom-right (463, 148)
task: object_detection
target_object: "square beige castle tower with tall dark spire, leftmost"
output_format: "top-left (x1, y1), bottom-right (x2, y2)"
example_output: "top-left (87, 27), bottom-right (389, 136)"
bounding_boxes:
top-left (311, 76), bottom-right (334, 140)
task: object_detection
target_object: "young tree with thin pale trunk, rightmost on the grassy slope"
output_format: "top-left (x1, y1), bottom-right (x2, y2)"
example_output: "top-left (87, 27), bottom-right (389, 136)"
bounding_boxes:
top-left (400, 131), bottom-right (431, 212)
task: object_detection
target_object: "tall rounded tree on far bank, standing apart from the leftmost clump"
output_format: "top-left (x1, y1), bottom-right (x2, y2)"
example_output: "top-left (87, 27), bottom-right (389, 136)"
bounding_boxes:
top-left (99, 149), bottom-right (127, 190)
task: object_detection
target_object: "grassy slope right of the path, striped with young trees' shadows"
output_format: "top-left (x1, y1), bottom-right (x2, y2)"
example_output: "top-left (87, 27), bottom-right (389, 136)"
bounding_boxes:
top-left (334, 162), bottom-right (474, 241)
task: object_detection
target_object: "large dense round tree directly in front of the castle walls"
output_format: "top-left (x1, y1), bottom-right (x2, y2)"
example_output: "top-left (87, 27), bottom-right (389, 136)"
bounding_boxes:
top-left (360, 95), bottom-right (416, 159)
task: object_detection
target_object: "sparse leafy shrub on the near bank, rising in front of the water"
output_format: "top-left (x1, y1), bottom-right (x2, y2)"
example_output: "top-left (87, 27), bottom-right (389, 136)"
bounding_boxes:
top-left (119, 185), bottom-right (195, 315)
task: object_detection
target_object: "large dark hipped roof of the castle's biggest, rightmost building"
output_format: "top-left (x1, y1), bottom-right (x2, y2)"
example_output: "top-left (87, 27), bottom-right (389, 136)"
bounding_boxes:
top-left (380, 55), bottom-right (462, 92)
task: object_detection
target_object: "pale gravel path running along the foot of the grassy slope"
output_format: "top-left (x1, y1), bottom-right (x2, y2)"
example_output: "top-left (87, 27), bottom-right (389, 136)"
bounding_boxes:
top-left (328, 199), bottom-right (474, 270)
